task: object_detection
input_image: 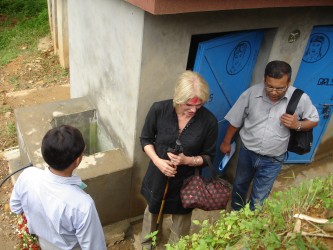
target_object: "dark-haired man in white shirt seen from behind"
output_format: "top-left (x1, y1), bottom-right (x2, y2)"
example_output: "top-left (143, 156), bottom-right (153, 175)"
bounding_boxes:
top-left (10, 125), bottom-right (106, 250)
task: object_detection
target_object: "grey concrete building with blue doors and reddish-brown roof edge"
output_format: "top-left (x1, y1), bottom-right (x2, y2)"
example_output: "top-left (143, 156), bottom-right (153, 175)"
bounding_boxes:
top-left (16, 0), bottom-right (333, 224)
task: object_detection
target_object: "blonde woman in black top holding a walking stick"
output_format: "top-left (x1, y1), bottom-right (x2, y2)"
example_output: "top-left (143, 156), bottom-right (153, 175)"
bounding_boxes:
top-left (140, 71), bottom-right (218, 249)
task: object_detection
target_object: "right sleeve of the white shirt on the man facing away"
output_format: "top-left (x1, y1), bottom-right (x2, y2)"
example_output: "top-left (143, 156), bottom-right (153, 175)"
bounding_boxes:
top-left (75, 200), bottom-right (106, 250)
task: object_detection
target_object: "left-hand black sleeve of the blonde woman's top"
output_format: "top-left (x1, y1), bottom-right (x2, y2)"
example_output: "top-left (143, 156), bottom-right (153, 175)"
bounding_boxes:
top-left (140, 103), bottom-right (157, 149)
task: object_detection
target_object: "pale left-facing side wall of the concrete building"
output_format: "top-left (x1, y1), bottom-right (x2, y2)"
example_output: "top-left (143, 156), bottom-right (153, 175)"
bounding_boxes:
top-left (68, 0), bottom-right (143, 160)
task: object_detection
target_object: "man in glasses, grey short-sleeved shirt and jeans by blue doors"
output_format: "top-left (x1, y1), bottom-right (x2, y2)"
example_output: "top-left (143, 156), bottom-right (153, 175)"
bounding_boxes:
top-left (220, 61), bottom-right (319, 210)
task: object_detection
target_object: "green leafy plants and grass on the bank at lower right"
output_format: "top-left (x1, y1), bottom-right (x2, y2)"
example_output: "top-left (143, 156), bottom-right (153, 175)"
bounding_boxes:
top-left (166, 173), bottom-right (333, 250)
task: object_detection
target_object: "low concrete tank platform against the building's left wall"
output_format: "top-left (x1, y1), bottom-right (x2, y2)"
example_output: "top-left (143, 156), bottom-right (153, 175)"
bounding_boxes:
top-left (10, 97), bottom-right (132, 225)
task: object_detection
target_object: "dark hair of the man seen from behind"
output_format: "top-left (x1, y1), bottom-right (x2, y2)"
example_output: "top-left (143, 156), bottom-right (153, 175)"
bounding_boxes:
top-left (42, 125), bottom-right (85, 171)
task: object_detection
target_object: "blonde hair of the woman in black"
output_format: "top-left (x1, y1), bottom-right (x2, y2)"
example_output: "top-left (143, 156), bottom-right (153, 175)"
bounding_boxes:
top-left (173, 70), bottom-right (209, 107)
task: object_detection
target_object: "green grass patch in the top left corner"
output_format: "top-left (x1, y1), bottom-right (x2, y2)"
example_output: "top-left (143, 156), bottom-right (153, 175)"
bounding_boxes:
top-left (0, 0), bottom-right (50, 65)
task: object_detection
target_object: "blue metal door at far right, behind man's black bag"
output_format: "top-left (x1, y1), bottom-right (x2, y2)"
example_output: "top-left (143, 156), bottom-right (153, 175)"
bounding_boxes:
top-left (286, 26), bottom-right (333, 163)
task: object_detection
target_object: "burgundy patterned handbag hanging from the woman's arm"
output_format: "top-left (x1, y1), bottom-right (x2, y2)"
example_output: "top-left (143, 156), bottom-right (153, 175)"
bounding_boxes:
top-left (180, 155), bottom-right (231, 211)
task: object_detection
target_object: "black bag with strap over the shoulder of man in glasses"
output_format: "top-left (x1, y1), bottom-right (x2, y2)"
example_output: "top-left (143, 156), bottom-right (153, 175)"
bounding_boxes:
top-left (286, 89), bottom-right (313, 155)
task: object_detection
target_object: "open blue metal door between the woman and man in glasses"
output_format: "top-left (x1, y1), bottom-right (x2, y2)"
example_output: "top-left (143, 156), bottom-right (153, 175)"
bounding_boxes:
top-left (193, 31), bottom-right (263, 173)
